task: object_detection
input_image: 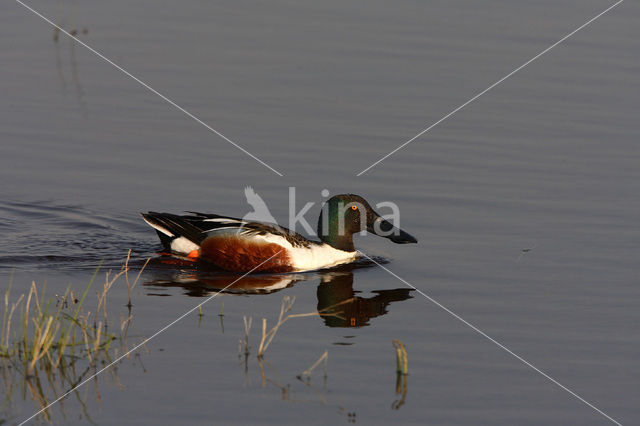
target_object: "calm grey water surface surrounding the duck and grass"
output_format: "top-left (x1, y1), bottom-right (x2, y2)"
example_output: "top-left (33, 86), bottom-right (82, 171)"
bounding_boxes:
top-left (0, 0), bottom-right (640, 424)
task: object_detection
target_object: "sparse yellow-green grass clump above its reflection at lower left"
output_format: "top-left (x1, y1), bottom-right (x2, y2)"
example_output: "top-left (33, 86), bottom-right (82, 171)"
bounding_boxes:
top-left (0, 256), bottom-right (146, 374)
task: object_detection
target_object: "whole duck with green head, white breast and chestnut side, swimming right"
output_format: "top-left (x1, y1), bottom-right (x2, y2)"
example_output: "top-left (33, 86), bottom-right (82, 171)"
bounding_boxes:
top-left (142, 194), bottom-right (418, 272)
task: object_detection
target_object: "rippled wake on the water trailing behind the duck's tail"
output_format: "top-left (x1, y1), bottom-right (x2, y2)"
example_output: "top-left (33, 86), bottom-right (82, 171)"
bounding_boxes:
top-left (0, 201), bottom-right (156, 270)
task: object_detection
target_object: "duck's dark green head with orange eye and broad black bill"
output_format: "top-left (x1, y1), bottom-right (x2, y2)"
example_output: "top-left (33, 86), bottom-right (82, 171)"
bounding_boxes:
top-left (318, 194), bottom-right (418, 251)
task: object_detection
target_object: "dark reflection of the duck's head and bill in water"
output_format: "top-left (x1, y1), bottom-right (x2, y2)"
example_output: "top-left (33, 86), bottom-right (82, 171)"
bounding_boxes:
top-left (317, 271), bottom-right (413, 327)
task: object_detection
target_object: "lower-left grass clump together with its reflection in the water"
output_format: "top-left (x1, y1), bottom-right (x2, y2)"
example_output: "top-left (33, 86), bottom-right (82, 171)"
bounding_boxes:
top-left (0, 253), bottom-right (146, 420)
